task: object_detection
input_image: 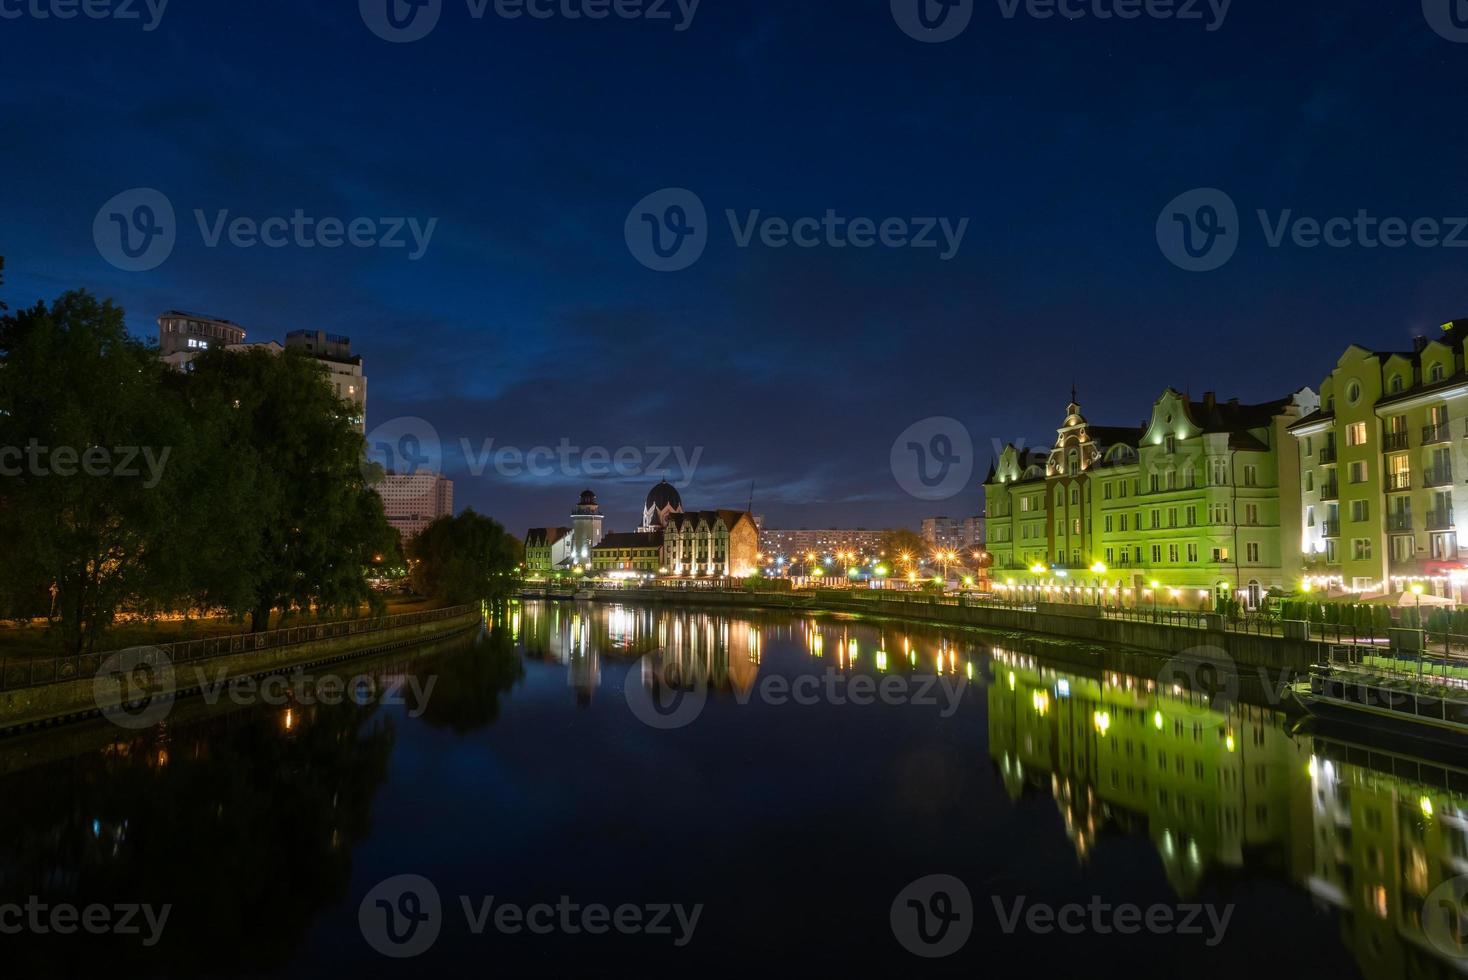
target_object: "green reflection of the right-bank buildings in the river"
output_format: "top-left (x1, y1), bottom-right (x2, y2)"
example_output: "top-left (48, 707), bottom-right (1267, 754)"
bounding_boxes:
top-left (988, 650), bottom-right (1468, 980)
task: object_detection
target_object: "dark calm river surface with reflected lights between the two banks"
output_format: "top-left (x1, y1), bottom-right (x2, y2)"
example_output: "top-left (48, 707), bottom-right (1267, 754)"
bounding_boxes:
top-left (0, 603), bottom-right (1468, 980)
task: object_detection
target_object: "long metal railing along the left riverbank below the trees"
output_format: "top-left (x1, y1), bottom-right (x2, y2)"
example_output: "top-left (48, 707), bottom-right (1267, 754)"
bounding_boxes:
top-left (0, 606), bottom-right (476, 691)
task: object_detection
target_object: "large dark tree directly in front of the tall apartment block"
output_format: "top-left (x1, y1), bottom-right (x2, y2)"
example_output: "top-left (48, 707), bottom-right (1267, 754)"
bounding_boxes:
top-left (188, 349), bottom-right (395, 632)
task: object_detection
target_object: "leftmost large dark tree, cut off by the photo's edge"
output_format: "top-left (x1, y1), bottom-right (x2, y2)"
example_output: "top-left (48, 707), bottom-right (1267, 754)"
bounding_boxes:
top-left (0, 292), bottom-right (189, 653)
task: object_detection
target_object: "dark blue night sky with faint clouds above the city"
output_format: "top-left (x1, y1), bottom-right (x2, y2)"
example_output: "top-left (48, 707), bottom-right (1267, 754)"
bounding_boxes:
top-left (0, 0), bottom-right (1468, 530)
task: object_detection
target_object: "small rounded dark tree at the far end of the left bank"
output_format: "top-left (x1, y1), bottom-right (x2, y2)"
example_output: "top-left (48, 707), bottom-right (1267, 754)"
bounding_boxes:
top-left (408, 511), bottom-right (523, 604)
